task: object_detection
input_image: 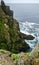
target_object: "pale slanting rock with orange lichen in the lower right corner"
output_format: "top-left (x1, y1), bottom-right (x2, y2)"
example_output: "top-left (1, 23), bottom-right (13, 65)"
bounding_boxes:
top-left (28, 42), bottom-right (39, 65)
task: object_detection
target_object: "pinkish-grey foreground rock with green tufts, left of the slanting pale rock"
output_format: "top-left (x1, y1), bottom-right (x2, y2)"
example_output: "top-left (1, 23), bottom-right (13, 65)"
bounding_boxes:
top-left (0, 51), bottom-right (30, 65)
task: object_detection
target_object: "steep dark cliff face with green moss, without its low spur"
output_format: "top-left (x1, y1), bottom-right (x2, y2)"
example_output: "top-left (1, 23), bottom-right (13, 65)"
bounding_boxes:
top-left (0, 1), bottom-right (30, 53)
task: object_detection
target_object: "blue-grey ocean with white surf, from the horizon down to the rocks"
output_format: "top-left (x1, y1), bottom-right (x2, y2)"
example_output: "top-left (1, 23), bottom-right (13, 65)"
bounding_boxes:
top-left (8, 3), bottom-right (39, 49)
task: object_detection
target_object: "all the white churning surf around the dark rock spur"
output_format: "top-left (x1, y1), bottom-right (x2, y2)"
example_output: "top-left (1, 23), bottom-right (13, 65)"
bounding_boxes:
top-left (19, 21), bottom-right (39, 48)
